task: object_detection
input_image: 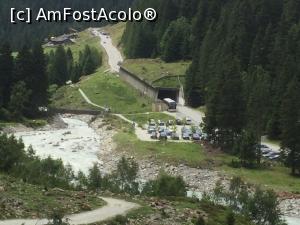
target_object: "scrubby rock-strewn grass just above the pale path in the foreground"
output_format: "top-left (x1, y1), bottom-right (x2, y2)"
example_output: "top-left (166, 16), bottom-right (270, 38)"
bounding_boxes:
top-left (0, 174), bottom-right (105, 219)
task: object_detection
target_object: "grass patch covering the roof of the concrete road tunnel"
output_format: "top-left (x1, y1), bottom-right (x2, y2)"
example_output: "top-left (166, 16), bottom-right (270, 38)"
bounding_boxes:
top-left (123, 59), bottom-right (190, 86)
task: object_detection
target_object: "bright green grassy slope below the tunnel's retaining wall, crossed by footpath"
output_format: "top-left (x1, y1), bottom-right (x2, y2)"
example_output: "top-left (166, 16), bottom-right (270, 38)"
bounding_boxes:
top-left (52, 69), bottom-right (151, 113)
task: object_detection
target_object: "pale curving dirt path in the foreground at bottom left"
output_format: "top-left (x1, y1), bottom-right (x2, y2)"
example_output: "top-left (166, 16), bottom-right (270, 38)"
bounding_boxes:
top-left (0, 198), bottom-right (139, 225)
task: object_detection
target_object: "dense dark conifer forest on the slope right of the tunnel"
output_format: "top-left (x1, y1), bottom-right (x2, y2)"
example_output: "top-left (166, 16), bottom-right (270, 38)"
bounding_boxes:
top-left (123, 0), bottom-right (300, 173)
